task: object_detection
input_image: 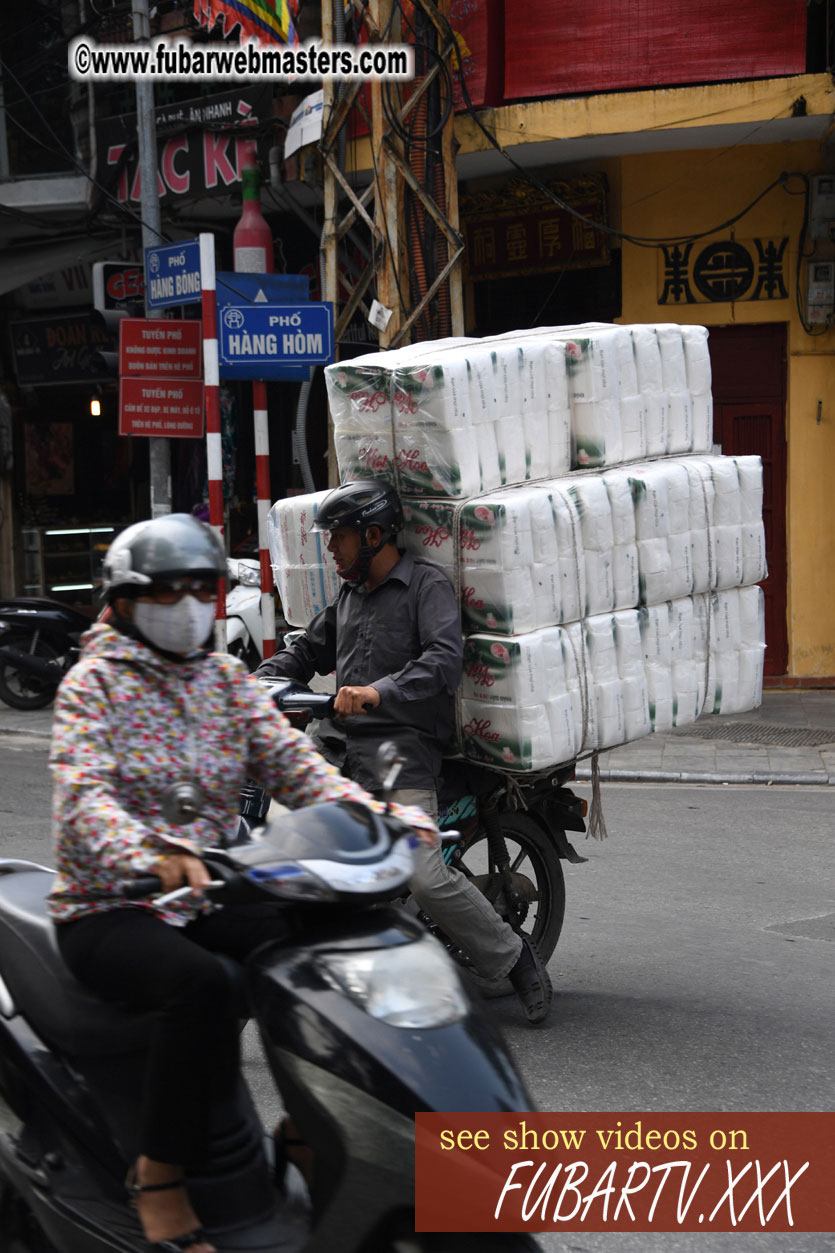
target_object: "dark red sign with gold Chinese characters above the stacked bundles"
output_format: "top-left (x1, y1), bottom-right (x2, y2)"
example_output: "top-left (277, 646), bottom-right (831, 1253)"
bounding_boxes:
top-left (461, 175), bottom-right (609, 279)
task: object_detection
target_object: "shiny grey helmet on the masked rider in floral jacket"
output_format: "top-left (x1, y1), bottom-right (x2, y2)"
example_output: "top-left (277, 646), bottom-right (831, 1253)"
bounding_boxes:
top-left (102, 514), bottom-right (226, 601)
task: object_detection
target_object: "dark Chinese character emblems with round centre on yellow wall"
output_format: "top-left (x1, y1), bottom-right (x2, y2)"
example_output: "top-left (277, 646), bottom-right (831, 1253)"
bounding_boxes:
top-left (658, 236), bottom-right (789, 304)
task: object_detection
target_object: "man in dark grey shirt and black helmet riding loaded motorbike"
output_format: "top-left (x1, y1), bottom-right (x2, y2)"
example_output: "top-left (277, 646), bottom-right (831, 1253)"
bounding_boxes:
top-left (256, 479), bottom-right (553, 1022)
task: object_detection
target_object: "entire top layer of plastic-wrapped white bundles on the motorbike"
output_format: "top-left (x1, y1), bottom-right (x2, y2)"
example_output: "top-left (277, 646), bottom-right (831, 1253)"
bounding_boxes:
top-left (325, 322), bottom-right (712, 500)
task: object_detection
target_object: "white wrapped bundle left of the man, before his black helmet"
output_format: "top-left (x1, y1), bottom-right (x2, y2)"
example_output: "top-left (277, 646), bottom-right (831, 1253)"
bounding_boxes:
top-left (267, 491), bottom-right (340, 627)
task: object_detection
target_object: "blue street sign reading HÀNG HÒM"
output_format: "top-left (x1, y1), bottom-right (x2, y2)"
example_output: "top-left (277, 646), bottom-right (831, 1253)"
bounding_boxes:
top-left (217, 302), bottom-right (333, 378)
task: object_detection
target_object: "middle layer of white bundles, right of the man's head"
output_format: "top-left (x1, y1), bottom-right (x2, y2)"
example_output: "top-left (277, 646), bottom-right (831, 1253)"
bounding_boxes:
top-left (404, 457), bottom-right (766, 635)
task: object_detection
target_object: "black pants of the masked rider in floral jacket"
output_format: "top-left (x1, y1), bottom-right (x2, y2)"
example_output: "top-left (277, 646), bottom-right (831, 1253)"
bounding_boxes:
top-left (55, 905), bottom-right (287, 1167)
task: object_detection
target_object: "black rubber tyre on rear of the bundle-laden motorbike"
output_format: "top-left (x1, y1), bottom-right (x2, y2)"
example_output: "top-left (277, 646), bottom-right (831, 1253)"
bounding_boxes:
top-left (453, 812), bottom-right (565, 999)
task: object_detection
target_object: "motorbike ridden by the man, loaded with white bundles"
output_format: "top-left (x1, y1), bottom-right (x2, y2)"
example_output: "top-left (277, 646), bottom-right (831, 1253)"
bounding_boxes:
top-left (241, 678), bottom-right (588, 996)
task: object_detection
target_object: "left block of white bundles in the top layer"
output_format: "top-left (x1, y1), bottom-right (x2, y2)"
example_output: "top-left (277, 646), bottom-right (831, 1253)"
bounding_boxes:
top-left (325, 340), bottom-right (570, 499)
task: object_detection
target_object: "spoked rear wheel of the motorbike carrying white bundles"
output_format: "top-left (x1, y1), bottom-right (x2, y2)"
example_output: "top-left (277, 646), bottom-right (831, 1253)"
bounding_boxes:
top-left (453, 813), bottom-right (565, 996)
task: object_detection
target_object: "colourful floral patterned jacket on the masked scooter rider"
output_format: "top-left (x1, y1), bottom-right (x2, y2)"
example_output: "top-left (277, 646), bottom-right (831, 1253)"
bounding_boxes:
top-left (48, 623), bottom-right (435, 926)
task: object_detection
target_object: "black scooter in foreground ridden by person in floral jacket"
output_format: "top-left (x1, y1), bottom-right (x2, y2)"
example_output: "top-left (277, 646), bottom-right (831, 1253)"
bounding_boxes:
top-left (0, 766), bottom-right (539, 1253)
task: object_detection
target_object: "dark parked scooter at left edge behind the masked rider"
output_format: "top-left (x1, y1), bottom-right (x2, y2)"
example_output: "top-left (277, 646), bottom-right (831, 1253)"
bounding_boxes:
top-left (0, 596), bottom-right (93, 709)
